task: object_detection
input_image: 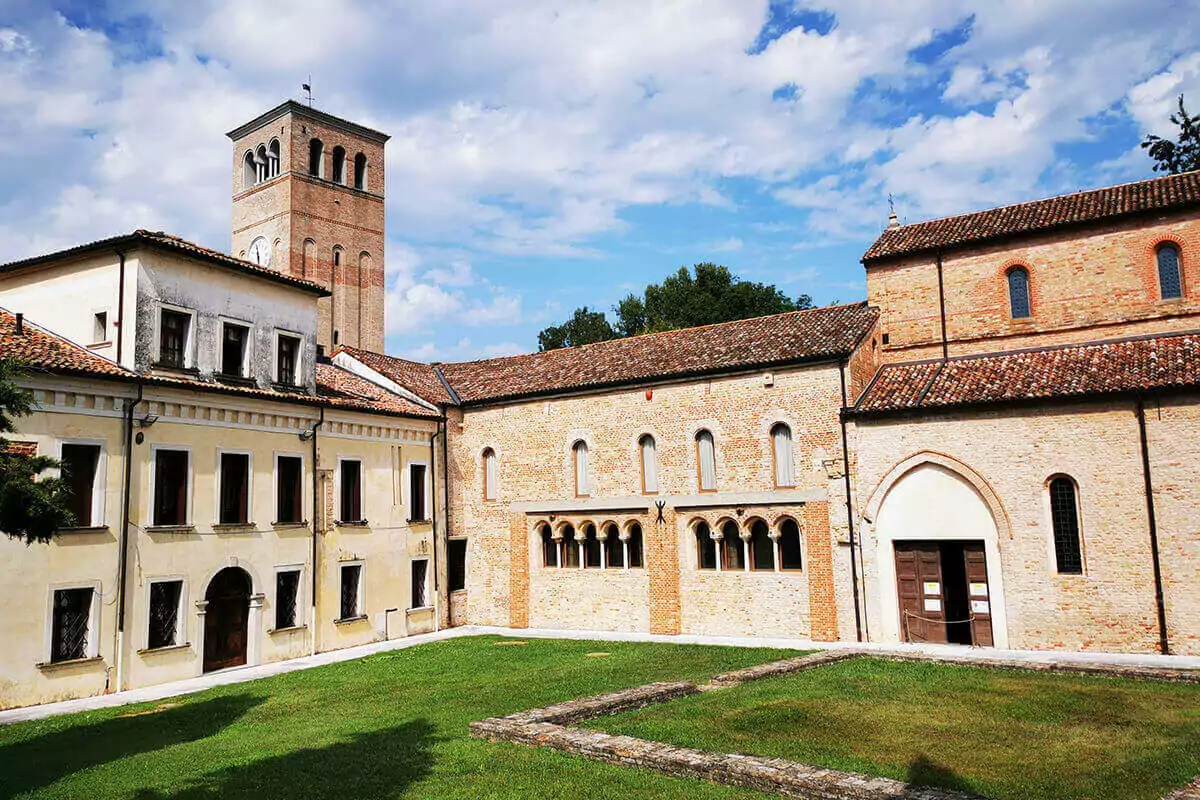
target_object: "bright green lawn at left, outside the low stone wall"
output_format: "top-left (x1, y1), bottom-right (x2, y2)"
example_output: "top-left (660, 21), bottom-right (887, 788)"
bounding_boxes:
top-left (0, 637), bottom-right (796, 800)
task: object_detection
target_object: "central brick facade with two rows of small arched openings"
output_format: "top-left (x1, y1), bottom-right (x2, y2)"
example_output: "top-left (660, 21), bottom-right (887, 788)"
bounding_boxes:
top-left (450, 365), bottom-right (845, 638)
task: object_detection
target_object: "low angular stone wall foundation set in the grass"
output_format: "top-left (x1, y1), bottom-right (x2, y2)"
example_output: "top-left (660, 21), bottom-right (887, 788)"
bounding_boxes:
top-left (470, 650), bottom-right (1200, 800)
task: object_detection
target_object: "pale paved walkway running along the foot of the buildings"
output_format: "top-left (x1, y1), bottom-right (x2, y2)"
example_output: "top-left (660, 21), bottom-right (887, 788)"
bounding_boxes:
top-left (7, 625), bottom-right (1200, 724)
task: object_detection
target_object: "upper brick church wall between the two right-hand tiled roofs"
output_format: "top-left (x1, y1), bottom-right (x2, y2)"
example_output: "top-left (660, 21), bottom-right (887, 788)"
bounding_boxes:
top-left (866, 210), bottom-right (1200, 360)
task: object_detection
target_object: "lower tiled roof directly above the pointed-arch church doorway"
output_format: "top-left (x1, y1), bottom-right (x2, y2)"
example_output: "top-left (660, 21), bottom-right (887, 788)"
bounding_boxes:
top-left (852, 332), bottom-right (1200, 416)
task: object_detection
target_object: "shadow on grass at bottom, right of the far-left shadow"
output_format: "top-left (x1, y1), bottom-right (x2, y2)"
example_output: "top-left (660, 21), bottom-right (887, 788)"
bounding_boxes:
top-left (133, 720), bottom-right (436, 800)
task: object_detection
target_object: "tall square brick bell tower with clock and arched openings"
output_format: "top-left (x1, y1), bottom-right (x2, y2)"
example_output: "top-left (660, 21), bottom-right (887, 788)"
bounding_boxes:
top-left (228, 100), bottom-right (389, 353)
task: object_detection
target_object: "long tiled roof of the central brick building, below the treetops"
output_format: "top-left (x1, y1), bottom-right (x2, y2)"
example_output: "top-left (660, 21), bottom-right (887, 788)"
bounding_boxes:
top-left (438, 302), bottom-right (877, 403)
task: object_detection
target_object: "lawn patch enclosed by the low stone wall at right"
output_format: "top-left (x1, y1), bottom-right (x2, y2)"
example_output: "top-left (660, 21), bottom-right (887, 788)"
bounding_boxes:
top-left (588, 658), bottom-right (1200, 800)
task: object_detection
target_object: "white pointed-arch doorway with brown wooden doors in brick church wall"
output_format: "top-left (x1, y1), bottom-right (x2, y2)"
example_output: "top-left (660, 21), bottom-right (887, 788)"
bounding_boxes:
top-left (872, 459), bottom-right (1008, 648)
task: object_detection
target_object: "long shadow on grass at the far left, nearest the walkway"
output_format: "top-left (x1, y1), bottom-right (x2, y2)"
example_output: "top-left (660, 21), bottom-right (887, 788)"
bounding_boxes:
top-left (0, 694), bottom-right (265, 800)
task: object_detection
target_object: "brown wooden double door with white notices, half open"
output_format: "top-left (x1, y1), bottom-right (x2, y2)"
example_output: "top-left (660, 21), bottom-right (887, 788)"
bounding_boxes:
top-left (895, 541), bottom-right (992, 648)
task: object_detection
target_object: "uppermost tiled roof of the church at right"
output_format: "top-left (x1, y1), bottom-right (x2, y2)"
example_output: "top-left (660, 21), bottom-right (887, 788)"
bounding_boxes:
top-left (863, 172), bottom-right (1200, 264)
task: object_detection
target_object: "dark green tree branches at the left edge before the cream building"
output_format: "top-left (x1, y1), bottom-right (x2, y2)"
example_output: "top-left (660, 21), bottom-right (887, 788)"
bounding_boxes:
top-left (0, 359), bottom-right (74, 543)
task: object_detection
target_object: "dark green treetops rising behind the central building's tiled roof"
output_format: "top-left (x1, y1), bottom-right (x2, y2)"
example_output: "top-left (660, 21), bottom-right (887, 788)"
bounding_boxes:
top-left (538, 263), bottom-right (812, 350)
